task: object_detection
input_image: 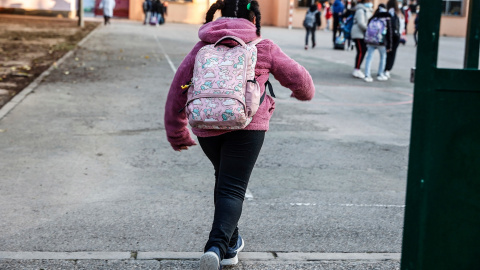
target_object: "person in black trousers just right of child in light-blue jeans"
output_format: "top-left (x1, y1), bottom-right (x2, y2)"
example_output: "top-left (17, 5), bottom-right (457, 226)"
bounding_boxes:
top-left (384, 0), bottom-right (405, 78)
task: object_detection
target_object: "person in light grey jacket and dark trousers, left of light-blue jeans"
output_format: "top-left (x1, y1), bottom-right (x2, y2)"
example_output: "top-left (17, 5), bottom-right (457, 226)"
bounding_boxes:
top-left (352, 0), bottom-right (373, 79)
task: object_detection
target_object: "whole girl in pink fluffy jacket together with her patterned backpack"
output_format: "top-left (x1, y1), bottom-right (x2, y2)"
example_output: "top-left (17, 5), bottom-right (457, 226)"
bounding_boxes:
top-left (164, 0), bottom-right (315, 270)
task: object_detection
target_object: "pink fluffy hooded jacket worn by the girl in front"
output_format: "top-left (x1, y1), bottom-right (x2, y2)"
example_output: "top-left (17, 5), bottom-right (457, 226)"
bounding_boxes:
top-left (165, 18), bottom-right (315, 150)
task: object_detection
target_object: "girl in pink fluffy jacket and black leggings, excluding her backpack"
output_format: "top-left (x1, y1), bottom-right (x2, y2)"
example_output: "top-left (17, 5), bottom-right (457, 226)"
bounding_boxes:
top-left (165, 0), bottom-right (315, 270)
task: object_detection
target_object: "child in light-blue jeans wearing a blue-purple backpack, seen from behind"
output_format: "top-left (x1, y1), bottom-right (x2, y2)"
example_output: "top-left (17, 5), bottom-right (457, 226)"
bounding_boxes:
top-left (364, 4), bottom-right (393, 82)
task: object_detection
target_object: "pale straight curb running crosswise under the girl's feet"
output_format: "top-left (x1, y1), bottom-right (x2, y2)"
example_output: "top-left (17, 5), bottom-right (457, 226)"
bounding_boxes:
top-left (0, 251), bottom-right (401, 261)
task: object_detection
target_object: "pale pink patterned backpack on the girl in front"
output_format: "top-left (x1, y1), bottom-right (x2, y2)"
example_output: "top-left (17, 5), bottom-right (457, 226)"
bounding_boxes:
top-left (185, 36), bottom-right (264, 129)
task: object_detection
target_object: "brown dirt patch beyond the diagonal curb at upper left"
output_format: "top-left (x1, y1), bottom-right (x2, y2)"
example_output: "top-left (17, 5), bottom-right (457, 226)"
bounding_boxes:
top-left (0, 15), bottom-right (99, 107)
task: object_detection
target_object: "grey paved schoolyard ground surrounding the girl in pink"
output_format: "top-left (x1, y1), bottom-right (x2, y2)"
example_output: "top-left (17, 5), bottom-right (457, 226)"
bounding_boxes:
top-left (0, 17), bottom-right (462, 269)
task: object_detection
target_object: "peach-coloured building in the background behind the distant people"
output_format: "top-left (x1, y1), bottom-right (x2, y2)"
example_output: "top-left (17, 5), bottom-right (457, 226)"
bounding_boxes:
top-left (0, 0), bottom-right (472, 37)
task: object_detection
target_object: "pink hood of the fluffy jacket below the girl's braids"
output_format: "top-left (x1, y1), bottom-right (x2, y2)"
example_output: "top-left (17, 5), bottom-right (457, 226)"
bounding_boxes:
top-left (198, 17), bottom-right (259, 43)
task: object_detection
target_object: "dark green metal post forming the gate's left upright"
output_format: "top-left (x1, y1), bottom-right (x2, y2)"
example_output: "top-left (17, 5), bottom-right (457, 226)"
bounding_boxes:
top-left (402, 0), bottom-right (442, 270)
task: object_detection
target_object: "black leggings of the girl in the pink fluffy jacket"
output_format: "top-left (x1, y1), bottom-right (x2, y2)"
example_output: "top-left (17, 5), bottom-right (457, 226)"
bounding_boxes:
top-left (198, 130), bottom-right (265, 259)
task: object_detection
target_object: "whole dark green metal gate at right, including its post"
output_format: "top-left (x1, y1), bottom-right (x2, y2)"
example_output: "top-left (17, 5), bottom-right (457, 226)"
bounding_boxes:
top-left (401, 0), bottom-right (480, 270)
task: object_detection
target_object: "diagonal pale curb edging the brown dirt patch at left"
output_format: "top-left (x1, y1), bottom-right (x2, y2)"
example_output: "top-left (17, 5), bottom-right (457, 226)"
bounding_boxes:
top-left (0, 24), bottom-right (102, 120)
